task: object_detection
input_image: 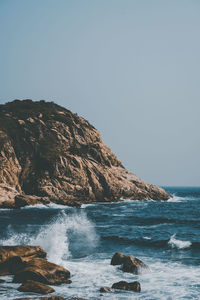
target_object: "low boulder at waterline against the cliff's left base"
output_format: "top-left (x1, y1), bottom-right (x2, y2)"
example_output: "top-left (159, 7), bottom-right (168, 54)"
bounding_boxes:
top-left (15, 195), bottom-right (50, 208)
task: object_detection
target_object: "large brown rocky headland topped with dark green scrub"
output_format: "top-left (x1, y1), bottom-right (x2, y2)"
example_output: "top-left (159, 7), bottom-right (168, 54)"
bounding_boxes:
top-left (0, 100), bottom-right (169, 207)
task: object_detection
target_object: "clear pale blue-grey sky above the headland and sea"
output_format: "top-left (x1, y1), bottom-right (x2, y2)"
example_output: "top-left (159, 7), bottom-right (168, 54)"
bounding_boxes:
top-left (0, 0), bottom-right (200, 185)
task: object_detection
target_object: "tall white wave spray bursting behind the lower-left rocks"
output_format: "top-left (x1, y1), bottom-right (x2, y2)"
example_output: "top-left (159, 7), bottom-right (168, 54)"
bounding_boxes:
top-left (0, 210), bottom-right (99, 264)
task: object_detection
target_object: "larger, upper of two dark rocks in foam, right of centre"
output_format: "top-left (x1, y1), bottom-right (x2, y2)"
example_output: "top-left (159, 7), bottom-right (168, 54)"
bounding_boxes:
top-left (111, 252), bottom-right (148, 275)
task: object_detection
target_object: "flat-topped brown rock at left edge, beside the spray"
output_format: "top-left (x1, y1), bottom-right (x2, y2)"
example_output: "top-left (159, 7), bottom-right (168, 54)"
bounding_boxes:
top-left (0, 246), bottom-right (46, 275)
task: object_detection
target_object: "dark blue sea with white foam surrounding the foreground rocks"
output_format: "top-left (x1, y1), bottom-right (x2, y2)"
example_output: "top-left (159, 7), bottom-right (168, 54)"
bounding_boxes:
top-left (0, 187), bottom-right (200, 300)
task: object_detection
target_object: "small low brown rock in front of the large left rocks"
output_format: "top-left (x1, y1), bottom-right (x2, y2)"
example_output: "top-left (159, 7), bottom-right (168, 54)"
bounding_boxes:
top-left (17, 280), bottom-right (55, 295)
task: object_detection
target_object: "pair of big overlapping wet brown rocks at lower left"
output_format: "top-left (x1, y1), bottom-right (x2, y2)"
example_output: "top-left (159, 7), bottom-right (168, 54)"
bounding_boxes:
top-left (0, 246), bottom-right (71, 285)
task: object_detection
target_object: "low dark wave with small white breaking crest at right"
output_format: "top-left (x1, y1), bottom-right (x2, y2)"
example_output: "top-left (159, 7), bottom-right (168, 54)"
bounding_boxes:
top-left (102, 235), bottom-right (200, 249)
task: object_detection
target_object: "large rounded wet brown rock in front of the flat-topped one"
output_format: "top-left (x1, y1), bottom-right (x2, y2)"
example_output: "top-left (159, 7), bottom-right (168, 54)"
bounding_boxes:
top-left (13, 258), bottom-right (71, 285)
